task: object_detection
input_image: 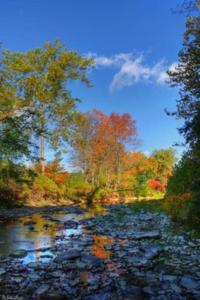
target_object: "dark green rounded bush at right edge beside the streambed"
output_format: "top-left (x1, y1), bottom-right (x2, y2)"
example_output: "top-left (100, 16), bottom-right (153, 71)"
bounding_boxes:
top-left (164, 153), bottom-right (200, 225)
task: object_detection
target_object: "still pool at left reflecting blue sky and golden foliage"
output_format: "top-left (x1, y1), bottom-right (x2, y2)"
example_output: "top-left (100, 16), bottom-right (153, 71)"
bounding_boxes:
top-left (0, 213), bottom-right (81, 263)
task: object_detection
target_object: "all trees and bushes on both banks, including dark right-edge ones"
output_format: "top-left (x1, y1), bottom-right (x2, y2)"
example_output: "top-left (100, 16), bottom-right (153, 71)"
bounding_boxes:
top-left (0, 12), bottom-right (200, 230)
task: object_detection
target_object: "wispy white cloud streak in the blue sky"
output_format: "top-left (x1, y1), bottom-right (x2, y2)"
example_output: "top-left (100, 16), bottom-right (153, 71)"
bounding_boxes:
top-left (90, 53), bottom-right (177, 92)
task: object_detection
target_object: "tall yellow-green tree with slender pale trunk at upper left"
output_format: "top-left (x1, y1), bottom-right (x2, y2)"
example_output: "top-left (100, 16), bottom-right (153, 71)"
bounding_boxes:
top-left (0, 41), bottom-right (93, 172)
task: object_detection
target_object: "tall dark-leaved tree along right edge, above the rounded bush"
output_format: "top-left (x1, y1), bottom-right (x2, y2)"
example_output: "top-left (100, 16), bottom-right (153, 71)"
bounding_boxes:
top-left (168, 17), bottom-right (200, 148)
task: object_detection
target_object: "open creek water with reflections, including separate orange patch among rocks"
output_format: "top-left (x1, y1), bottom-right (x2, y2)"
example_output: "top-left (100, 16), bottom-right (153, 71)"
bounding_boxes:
top-left (0, 207), bottom-right (109, 264)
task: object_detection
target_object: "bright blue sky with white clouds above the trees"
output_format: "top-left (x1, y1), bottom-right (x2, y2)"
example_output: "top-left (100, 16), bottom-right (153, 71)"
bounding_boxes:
top-left (0, 0), bottom-right (188, 162)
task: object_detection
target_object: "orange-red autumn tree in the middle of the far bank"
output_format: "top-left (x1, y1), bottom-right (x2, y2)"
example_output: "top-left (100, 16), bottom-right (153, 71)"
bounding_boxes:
top-left (73, 110), bottom-right (137, 188)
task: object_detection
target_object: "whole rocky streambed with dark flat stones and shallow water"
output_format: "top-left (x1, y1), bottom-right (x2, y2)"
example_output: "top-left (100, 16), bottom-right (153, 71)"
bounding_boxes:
top-left (0, 205), bottom-right (200, 300)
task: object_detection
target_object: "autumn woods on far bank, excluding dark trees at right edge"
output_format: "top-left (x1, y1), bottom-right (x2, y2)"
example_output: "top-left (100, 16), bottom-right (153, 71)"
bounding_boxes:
top-left (0, 41), bottom-right (175, 206)
